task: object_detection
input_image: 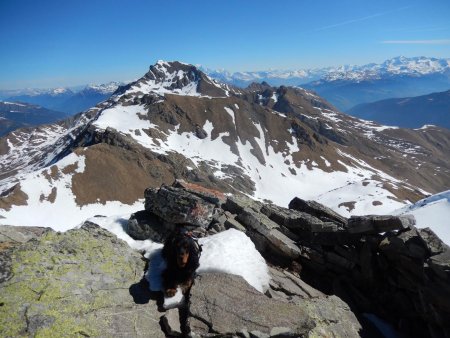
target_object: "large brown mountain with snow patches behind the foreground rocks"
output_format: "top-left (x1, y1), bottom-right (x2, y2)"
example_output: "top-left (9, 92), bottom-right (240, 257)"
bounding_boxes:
top-left (0, 61), bottom-right (450, 227)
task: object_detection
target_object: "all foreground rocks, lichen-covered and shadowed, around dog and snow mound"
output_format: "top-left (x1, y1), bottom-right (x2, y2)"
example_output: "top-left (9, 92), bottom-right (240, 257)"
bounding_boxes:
top-left (0, 181), bottom-right (450, 337)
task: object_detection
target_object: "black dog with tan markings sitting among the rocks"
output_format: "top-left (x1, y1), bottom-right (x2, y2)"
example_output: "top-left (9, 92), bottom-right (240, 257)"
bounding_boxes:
top-left (162, 229), bottom-right (202, 297)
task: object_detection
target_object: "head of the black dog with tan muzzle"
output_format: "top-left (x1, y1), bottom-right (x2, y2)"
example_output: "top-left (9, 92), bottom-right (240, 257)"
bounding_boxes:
top-left (163, 230), bottom-right (200, 270)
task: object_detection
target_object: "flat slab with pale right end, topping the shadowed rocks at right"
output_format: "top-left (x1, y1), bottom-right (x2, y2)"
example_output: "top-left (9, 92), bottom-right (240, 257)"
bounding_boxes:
top-left (348, 215), bottom-right (416, 234)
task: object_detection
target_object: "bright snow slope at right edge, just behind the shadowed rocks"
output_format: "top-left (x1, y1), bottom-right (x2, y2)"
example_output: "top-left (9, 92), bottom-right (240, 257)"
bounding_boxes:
top-left (392, 190), bottom-right (450, 245)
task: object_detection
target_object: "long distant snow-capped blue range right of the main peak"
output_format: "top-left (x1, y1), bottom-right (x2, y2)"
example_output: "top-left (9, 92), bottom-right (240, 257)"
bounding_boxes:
top-left (205, 56), bottom-right (450, 111)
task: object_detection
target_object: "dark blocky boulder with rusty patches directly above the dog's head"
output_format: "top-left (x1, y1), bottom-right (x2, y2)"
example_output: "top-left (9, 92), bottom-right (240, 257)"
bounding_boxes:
top-left (145, 185), bottom-right (214, 228)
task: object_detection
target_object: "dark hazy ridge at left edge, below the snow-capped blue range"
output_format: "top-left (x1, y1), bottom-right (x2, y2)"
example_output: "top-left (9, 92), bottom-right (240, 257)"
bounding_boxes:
top-left (0, 101), bottom-right (68, 136)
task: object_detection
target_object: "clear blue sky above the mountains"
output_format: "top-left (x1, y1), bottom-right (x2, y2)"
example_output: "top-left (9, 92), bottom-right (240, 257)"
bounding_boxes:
top-left (0, 0), bottom-right (450, 89)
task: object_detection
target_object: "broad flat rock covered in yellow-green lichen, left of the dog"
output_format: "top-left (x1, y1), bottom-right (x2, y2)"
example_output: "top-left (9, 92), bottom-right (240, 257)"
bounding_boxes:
top-left (0, 223), bottom-right (164, 337)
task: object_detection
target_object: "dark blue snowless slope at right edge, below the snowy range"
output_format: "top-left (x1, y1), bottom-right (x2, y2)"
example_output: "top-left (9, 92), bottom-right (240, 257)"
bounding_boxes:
top-left (348, 90), bottom-right (450, 129)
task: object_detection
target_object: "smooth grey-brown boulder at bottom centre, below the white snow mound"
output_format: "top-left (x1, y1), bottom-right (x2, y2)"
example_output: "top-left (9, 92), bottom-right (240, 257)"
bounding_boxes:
top-left (189, 270), bottom-right (361, 337)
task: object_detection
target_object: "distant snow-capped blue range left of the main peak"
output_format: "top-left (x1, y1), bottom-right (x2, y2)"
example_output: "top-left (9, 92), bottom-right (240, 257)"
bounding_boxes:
top-left (0, 82), bottom-right (121, 115)
